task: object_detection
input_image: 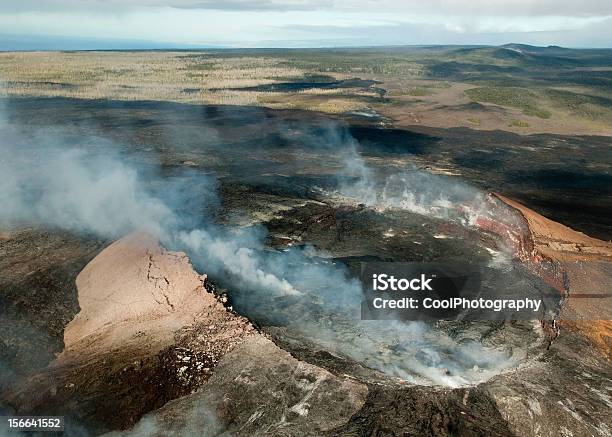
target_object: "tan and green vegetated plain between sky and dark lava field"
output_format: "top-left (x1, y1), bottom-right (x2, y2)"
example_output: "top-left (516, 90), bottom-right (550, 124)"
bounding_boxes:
top-left (0, 44), bottom-right (612, 134)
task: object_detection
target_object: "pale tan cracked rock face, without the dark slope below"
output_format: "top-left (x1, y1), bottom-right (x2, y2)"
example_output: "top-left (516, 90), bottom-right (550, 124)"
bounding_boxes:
top-left (64, 234), bottom-right (215, 354)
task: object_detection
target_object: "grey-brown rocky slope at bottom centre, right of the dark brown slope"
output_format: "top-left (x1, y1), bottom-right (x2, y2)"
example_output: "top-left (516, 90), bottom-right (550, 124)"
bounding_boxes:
top-left (112, 335), bottom-right (368, 436)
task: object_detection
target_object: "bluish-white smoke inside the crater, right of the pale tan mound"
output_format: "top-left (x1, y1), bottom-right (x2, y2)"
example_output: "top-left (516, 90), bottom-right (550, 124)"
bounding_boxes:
top-left (175, 228), bottom-right (520, 387)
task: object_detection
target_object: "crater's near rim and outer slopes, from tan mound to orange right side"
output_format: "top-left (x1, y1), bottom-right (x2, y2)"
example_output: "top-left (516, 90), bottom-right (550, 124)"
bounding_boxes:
top-left (0, 198), bottom-right (612, 436)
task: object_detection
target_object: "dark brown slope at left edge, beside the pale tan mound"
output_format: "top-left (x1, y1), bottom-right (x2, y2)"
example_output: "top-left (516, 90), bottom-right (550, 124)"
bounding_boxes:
top-left (0, 227), bottom-right (105, 391)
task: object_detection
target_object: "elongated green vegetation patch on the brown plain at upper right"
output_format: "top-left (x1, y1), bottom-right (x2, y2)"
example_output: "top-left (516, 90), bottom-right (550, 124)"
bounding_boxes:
top-left (465, 87), bottom-right (551, 118)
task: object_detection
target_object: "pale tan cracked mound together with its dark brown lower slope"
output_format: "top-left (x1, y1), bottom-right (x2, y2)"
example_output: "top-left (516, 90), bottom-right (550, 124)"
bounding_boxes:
top-left (0, 230), bottom-right (254, 435)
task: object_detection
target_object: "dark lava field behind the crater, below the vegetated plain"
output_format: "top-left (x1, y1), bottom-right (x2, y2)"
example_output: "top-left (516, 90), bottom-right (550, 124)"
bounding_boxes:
top-left (5, 98), bottom-right (612, 240)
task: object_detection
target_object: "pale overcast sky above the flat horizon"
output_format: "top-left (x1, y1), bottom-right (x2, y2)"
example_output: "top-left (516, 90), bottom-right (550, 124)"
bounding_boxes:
top-left (0, 0), bottom-right (612, 50)
